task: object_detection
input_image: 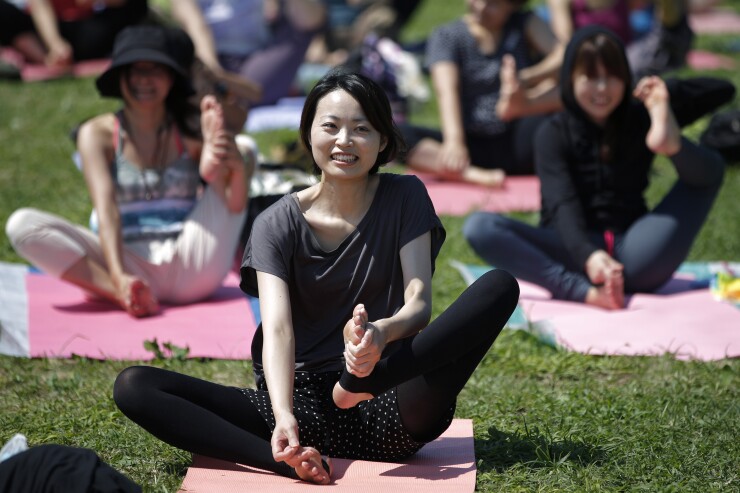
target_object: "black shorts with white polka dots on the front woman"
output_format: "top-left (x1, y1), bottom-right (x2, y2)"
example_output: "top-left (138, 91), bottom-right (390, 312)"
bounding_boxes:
top-left (240, 371), bottom-right (454, 462)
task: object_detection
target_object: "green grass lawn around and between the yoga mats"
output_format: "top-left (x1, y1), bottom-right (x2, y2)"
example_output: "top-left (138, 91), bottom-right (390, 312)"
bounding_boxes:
top-left (0, 0), bottom-right (740, 492)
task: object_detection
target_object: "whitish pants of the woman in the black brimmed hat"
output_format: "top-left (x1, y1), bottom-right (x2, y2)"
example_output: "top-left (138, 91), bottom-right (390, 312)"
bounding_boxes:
top-left (5, 187), bottom-right (246, 304)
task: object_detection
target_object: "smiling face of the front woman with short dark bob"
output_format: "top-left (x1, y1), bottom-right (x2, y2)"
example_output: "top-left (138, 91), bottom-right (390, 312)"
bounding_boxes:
top-left (310, 89), bottom-right (387, 178)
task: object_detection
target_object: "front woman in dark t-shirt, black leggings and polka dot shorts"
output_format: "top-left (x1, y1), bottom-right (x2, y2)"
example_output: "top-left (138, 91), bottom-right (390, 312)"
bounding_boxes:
top-left (114, 67), bottom-right (519, 484)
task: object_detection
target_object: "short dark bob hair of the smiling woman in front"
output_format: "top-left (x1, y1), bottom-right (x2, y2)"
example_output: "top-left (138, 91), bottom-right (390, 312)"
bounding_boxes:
top-left (300, 68), bottom-right (405, 175)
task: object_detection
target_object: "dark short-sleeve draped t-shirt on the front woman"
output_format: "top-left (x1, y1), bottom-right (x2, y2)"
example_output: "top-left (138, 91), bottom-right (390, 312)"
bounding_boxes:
top-left (240, 173), bottom-right (445, 371)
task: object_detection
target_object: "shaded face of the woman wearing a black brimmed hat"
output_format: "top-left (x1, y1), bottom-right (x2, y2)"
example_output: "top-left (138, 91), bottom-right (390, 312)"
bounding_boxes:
top-left (121, 62), bottom-right (174, 103)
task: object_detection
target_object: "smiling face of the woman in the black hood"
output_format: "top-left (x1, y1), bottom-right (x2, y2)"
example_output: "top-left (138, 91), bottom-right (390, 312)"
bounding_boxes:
top-left (573, 61), bottom-right (625, 125)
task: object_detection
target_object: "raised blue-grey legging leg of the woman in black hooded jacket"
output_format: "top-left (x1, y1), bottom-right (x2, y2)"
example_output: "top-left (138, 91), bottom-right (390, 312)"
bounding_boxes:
top-left (616, 138), bottom-right (724, 292)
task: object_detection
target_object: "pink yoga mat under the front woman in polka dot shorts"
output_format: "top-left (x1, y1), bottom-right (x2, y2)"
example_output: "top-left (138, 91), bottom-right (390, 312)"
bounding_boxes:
top-left (180, 419), bottom-right (475, 493)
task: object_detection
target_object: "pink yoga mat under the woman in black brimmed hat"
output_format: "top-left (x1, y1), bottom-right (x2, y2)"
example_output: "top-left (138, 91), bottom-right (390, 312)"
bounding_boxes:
top-left (26, 274), bottom-right (256, 360)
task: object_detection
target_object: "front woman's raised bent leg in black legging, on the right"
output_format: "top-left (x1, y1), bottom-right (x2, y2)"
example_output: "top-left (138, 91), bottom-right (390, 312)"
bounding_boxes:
top-left (334, 270), bottom-right (519, 439)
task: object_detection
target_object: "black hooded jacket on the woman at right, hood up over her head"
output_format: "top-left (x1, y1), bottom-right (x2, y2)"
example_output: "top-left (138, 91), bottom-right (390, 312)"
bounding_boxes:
top-left (534, 26), bottom-right (735, 266)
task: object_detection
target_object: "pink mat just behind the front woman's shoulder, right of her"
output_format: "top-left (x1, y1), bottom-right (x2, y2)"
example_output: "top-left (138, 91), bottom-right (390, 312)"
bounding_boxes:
top-left (414, 172), bottom-right (540, 216)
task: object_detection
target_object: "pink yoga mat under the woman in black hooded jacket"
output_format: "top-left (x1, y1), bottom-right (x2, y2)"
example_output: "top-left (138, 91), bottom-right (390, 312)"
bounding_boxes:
top-left (519, 277), bottom-right (740, 361)
